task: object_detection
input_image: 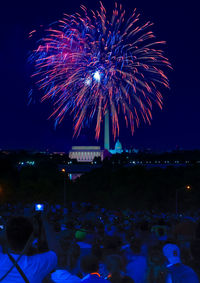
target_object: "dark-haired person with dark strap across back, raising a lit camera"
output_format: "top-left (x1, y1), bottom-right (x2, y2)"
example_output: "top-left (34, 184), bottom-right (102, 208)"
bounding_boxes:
top-left (0, 217), bottom-right (57, 283)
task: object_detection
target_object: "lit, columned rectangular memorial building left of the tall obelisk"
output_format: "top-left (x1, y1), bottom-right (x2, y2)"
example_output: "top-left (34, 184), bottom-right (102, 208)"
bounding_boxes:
top-left (69, 146), bottom-right (103, 162)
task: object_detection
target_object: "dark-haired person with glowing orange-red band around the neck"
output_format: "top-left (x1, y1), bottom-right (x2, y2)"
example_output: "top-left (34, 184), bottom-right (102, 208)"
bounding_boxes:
top-left (81, 254), bottom-right (108, 283)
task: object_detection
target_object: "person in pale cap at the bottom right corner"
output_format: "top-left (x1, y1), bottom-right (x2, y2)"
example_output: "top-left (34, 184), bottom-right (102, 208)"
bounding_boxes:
top-left (163, 244), bottom-right (199, 283)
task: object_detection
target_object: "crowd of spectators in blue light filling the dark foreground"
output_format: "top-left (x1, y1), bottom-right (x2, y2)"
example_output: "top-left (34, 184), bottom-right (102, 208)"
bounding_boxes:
top-left (0, 202), bottom-right (200, 283)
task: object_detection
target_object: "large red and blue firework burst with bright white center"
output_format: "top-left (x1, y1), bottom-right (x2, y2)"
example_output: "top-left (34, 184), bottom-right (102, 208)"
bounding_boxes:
top-left (29, 2), bottom-right (171, 139)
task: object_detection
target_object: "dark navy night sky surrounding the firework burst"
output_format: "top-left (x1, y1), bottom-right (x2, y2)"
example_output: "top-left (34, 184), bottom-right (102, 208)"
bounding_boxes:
top-left (0, 0), bottom-right (200, 151)
